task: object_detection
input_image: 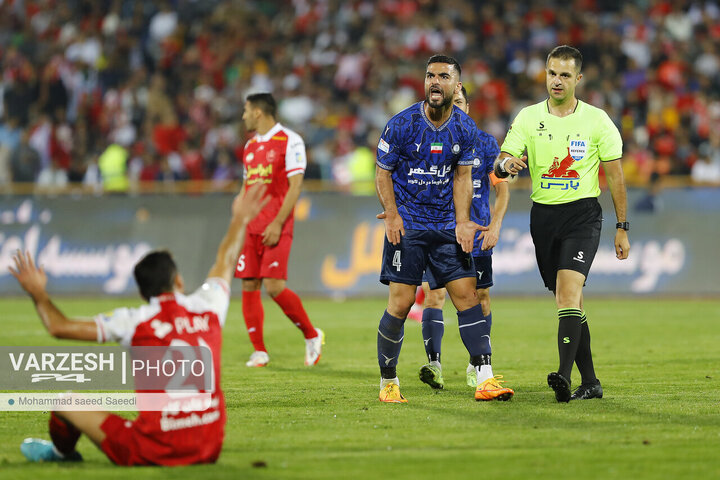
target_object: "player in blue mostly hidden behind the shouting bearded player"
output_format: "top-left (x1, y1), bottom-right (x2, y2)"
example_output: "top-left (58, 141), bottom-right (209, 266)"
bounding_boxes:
top-left (420, 87), bottom-right (510, 395)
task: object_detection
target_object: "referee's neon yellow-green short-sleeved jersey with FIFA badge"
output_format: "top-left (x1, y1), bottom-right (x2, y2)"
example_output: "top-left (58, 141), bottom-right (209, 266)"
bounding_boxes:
top-left (501, 100), bottom-right (622, 205)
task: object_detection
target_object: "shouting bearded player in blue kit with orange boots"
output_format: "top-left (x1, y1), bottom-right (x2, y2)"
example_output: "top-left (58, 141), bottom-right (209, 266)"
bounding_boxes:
top-left (375, 55), bottom-right (514, 403)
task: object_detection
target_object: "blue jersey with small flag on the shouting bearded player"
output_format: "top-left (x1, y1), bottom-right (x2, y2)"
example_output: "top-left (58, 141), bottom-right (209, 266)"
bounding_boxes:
top-left (377, 102), bottom-right (479, 230)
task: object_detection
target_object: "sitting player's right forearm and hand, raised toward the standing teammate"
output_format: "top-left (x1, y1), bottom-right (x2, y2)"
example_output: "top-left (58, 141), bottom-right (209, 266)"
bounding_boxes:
top-left (208, 184), bottom-right (270, 283)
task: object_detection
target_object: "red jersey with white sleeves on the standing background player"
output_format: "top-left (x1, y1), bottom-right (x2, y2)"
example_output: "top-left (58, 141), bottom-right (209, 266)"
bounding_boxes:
top-left (243, 123), bottom-right (307, 235)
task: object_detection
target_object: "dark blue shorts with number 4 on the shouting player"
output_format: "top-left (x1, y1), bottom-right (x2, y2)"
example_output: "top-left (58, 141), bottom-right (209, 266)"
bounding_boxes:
top-left (380, 230), bottom-right (476, 288)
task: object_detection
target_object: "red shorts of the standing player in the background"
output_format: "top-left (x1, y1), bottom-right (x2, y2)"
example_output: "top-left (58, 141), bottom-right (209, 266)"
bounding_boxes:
top-left (235, 233), bottom-right (292, 280)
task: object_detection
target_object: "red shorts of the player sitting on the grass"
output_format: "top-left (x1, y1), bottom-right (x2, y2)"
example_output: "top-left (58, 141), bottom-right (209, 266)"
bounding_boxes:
top-left (100, 414), bottom-right (223, 466)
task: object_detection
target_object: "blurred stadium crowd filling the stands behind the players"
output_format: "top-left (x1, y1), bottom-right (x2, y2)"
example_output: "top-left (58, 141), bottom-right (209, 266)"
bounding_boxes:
top-left (0, 0), bottom-right (720, 192)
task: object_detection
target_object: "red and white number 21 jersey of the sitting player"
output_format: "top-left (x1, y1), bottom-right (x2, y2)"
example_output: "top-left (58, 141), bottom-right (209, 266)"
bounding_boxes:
top-left (94, 278), bottom-right (230, 464)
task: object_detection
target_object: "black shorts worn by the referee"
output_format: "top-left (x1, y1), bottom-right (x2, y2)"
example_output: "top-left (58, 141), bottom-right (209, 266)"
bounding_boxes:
top-left (530, 198), bottom-right (602, 292)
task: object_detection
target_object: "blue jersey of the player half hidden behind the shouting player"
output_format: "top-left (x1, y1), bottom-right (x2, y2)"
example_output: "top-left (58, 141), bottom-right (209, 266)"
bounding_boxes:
top-left (470, 129), bottom-right (500, 257)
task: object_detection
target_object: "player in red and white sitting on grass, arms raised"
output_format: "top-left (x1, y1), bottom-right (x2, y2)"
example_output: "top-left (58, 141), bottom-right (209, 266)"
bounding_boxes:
top-left (10, 186), bottom-right (267, 465)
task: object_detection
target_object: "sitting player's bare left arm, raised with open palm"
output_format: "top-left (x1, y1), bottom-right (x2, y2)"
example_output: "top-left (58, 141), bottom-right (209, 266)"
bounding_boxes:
top-left (9, 250), bottom-right (97, 340)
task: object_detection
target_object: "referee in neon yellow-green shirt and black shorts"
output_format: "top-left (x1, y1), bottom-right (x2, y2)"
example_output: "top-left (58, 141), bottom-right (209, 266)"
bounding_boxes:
top-left (495, 45), bottom-right (630, 402)
